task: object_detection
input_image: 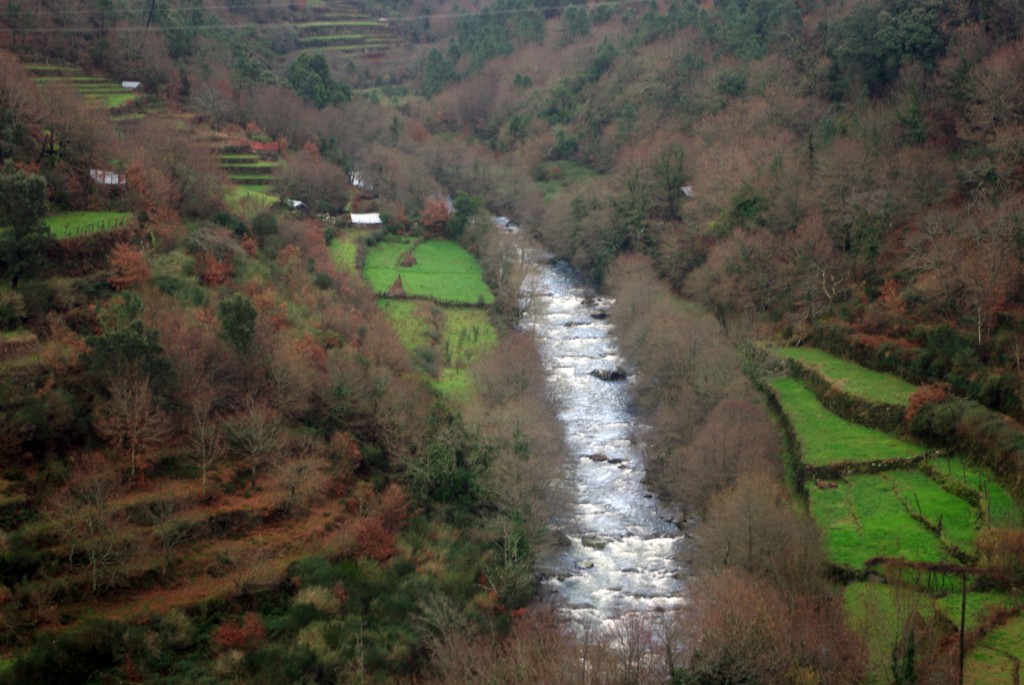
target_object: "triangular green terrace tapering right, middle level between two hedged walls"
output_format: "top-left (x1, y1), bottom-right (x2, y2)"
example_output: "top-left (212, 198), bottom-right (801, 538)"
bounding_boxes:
top-left (771, 378), bottom-right (924, 466)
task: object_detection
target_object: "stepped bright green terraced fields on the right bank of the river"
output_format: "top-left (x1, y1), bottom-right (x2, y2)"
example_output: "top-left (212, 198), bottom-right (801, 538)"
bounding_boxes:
top-left (771, 350), bottom-right (1024, 685)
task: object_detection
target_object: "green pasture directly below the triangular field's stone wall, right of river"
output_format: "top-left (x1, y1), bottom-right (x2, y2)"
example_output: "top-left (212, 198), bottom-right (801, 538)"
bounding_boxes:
top-left (809, 474), bottom-right (951, 569)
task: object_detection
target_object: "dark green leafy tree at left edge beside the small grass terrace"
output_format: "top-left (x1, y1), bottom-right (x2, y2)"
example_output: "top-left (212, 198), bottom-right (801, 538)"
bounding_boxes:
top-left (0, 160), bottom-right (52, 290)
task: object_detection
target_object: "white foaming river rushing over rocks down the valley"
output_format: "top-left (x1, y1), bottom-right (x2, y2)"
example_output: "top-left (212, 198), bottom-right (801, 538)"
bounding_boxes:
top-left (503, 220), bottom-right (685, 624)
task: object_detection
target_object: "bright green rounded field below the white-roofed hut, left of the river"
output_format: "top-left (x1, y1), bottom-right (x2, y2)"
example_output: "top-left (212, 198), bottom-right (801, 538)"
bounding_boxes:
top-left (362, 241), bottom-right (495, 304)
